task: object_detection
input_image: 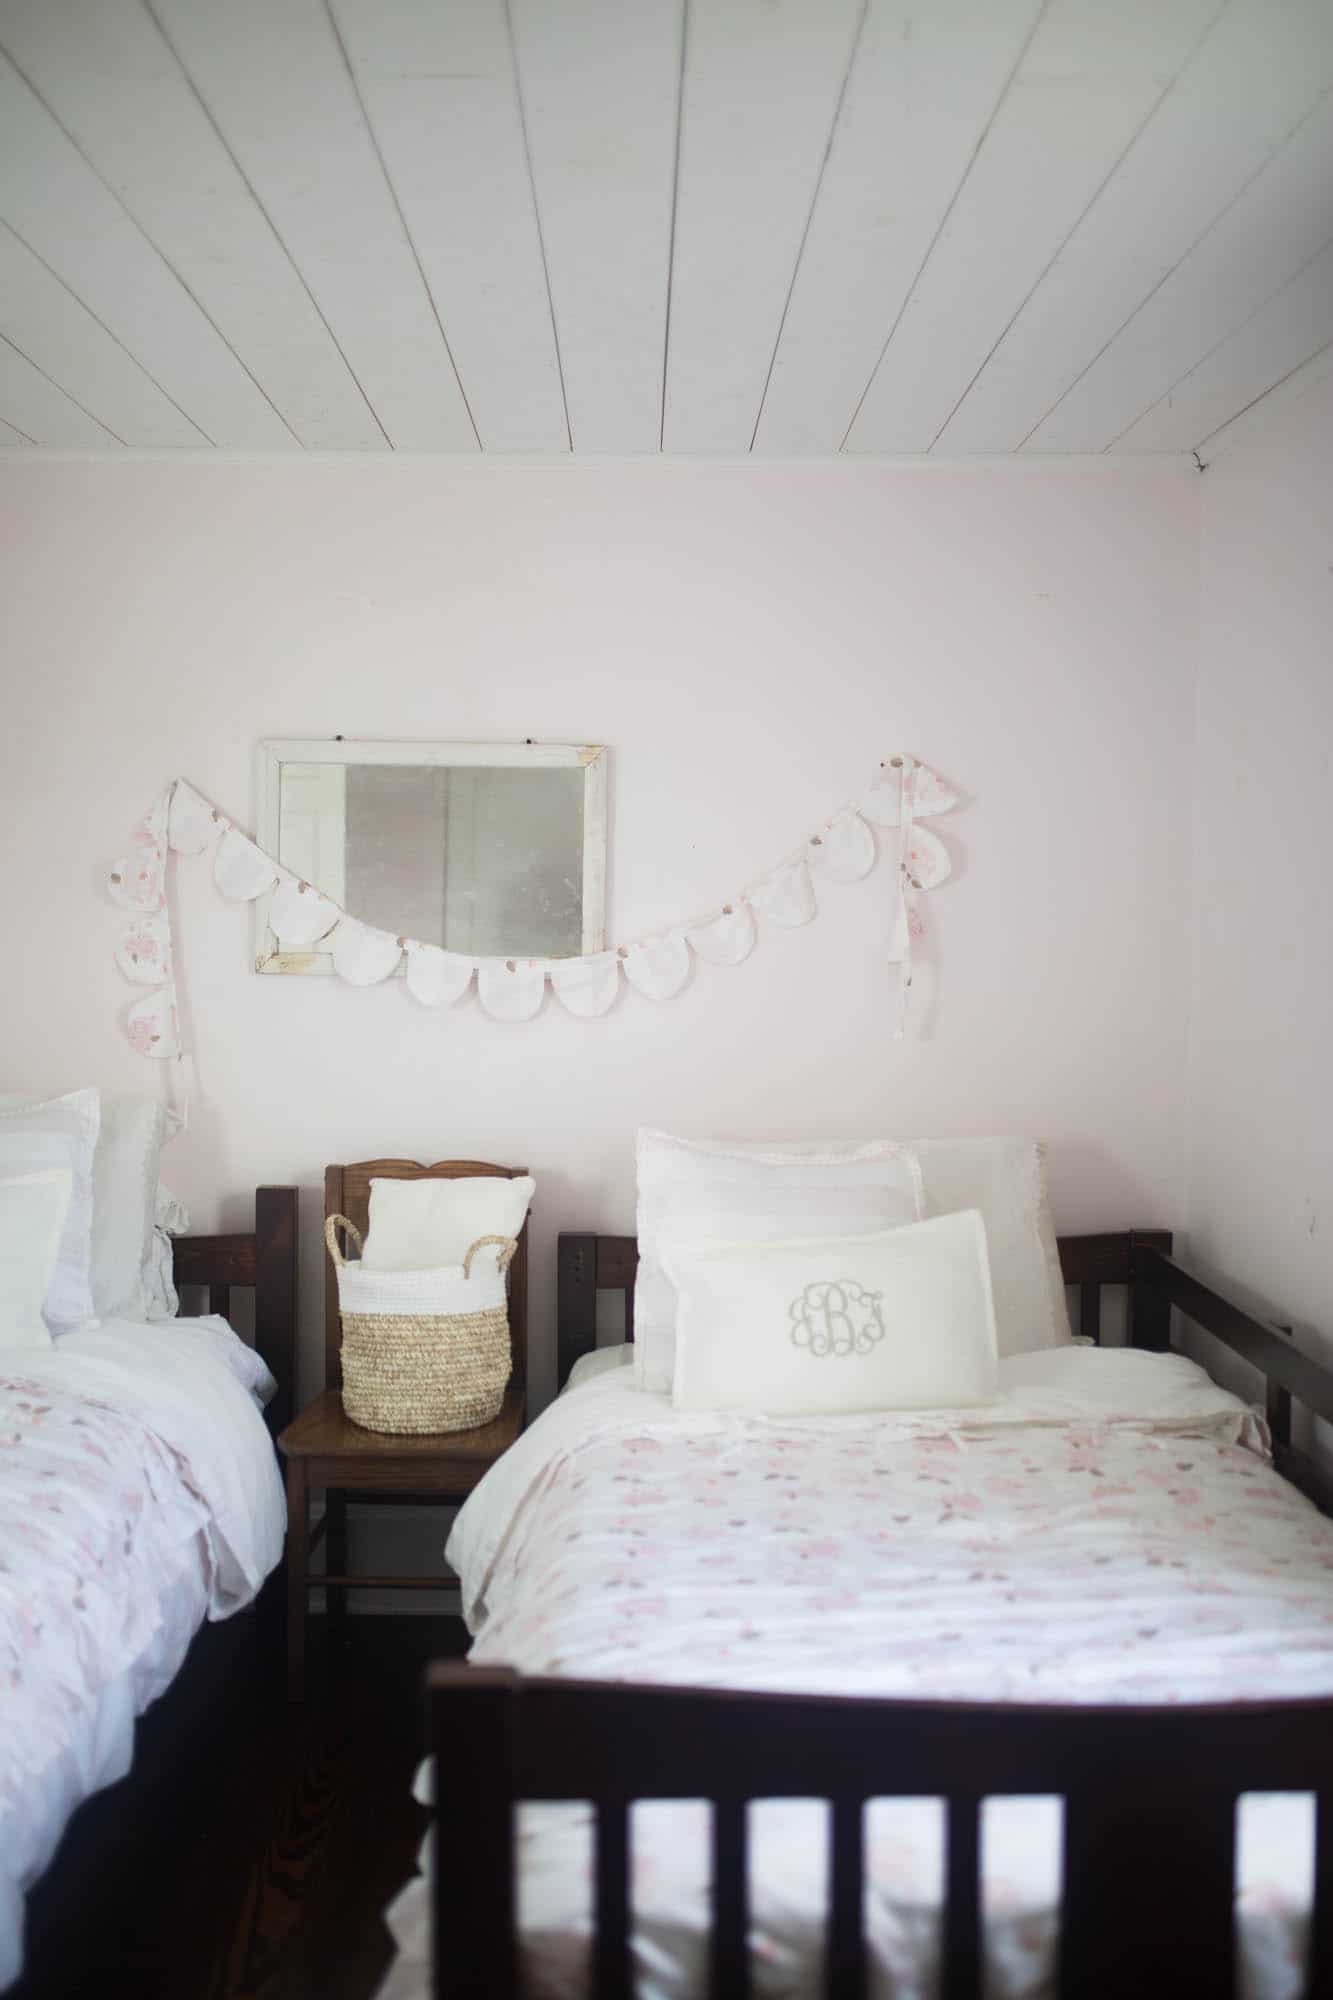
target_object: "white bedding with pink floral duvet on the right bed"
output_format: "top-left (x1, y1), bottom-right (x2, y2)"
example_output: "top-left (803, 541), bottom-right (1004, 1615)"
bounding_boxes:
top-left (382, 1348), bottom-right (1333, 2000)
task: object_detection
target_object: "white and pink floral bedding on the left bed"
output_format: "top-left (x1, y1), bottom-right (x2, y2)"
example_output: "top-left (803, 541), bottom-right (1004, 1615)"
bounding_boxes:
top-left (0, 1318), bottom-right (286, 1988)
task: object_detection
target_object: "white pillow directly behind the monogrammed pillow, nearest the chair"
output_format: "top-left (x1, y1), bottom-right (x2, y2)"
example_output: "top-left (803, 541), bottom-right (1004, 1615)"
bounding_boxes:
top-left (634, 1132), bottom-right (925, 1392)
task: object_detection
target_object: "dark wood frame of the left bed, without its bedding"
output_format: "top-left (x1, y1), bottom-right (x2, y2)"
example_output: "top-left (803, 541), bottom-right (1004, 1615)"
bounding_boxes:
top-left (6, 1188), bottom-right (296, 2000)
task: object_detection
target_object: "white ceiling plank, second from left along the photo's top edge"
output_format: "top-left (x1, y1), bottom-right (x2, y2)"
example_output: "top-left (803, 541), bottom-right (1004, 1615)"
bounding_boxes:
top-left (152, 0), bottom-right (476, 452)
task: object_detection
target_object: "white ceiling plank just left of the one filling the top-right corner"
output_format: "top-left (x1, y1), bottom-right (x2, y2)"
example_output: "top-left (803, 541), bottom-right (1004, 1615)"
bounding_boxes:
top-left (845, 0), bottom-right (1219, 452)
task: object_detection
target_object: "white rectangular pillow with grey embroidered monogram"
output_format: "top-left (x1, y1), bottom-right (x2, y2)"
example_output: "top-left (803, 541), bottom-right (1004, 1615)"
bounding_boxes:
top-left (664, 1208), bottom-right (997, 1416)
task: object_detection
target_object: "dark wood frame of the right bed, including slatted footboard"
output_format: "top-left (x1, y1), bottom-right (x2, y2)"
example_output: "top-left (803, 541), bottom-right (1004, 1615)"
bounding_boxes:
top-left (428, 1230), bottom-right (1333, 2000)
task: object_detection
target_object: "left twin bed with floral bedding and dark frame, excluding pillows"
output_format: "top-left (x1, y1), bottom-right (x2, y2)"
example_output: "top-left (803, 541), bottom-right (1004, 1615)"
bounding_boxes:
top-left (0, 1188), bottom-right (296, 1992)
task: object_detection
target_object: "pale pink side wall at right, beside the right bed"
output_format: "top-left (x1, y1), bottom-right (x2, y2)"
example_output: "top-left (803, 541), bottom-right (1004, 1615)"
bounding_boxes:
top-left (1187, 384), bottom-right (1333, 1358)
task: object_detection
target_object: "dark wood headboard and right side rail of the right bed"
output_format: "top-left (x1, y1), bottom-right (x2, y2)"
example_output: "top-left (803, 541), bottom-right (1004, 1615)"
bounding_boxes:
top-left (556, 1230), bottom-right (1333, 1514)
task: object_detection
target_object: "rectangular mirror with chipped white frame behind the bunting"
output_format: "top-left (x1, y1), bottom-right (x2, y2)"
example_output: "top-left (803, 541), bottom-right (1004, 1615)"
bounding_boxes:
top-left (254, 740), bottom-right (606, 972)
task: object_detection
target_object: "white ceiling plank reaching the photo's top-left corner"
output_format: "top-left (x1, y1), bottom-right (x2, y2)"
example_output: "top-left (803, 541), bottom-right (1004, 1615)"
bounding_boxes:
top-left (0, 0), bottom-right (384, 450)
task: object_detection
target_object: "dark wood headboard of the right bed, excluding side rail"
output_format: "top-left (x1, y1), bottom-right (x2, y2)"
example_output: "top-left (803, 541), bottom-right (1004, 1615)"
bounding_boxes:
top-left (556, 1230), bottom-right (1171, 1388)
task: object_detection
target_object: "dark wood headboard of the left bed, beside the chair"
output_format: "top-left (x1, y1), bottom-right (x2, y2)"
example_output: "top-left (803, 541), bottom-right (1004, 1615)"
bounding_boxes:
top-left (172, 1188), bottom-right (296, 1436)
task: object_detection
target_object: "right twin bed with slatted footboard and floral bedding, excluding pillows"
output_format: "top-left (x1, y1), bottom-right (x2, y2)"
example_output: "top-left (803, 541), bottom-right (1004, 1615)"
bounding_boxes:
top-left (382, 1234), bottom-right (1333, 2000)
